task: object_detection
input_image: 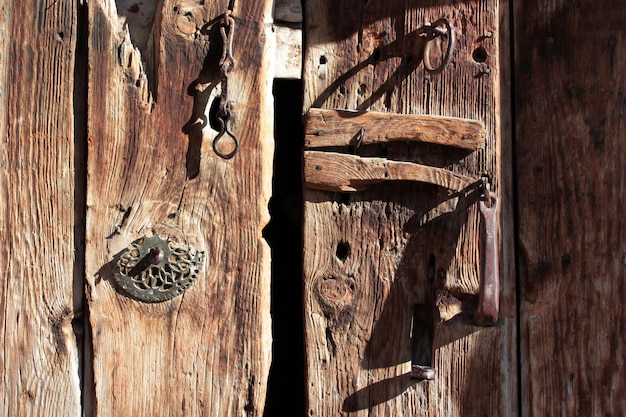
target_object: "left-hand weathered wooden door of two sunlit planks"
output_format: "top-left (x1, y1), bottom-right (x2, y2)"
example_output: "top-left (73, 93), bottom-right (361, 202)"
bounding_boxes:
top-left (0, 0), bottom-right (273, 416)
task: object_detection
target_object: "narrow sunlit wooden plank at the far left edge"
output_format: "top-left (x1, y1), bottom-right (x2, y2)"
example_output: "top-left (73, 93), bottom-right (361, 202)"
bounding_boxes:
top-left (0, 1), bottom-right (81, 416)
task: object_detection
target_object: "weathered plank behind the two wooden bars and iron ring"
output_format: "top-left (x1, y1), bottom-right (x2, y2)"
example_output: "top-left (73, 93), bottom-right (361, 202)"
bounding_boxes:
top-left (303, 0), bottom-right (517, 416)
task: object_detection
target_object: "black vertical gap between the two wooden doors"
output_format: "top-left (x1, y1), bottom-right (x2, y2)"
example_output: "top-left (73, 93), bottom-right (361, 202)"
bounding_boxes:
top-left (263, 79), bottom-right (305, 417)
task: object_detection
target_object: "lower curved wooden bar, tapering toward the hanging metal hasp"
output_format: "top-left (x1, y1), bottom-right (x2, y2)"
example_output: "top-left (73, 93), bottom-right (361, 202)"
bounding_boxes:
top-left (304, 151), bottom-right (475, 191)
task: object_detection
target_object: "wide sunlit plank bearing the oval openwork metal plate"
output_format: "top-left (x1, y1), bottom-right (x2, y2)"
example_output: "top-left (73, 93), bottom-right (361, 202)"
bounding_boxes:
top-left (86, 0), bottom-right (274, 416)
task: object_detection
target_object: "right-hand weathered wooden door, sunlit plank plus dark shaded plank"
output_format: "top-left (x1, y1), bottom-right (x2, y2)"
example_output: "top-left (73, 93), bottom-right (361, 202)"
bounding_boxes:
top-left (303, 0), bottom-right (626, 416)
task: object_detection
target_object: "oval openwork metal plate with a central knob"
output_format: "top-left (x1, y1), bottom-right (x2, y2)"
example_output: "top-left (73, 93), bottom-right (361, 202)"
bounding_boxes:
top-left (115, 234), bottom-right (204, 303)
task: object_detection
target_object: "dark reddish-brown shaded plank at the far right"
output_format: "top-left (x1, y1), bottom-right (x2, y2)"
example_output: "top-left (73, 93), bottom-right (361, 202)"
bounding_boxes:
top-left (515, 0), bottom-right (626, 416)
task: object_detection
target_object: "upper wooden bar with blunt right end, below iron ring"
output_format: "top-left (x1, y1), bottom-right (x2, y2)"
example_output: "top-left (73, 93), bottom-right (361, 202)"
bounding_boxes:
top-left (304, 108), bottom-right (486, 151)
